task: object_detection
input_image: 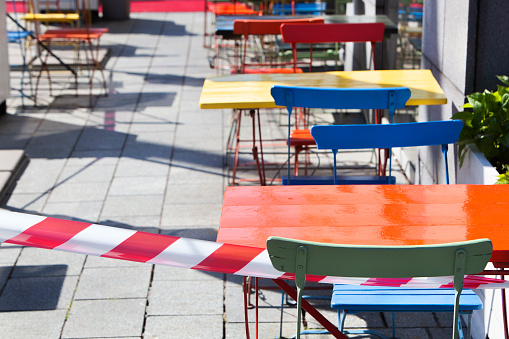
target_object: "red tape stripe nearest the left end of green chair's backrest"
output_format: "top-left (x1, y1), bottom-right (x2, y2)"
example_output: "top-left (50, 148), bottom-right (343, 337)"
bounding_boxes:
top-left (193, 244), bottom-right (264, 274)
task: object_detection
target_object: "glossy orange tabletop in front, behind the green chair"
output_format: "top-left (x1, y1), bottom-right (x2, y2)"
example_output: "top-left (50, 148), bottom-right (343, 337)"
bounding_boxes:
top-left (217, 185), bottom-right (509, 263)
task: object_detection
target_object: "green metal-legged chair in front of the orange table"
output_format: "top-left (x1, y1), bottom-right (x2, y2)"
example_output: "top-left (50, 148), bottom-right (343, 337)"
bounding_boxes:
top-left (267, 237), bottom-right (492, 339)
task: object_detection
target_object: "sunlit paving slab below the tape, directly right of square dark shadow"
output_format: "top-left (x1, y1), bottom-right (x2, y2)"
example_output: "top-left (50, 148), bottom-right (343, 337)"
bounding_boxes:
top-left (74, 265), bottom-right (152, 300)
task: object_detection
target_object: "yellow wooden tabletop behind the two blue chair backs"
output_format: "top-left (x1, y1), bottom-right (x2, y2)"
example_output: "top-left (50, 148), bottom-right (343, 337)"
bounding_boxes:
top-left (200, 69), bottom-right (447, 109)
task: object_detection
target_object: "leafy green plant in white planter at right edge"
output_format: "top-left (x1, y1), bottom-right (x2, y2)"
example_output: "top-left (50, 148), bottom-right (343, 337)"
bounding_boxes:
top-left (452, 76), bottom-right (509, 182)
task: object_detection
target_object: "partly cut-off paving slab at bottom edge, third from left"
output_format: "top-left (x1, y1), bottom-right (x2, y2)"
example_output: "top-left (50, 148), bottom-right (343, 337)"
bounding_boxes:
top-left (144, 315), bottom-right (224, 339)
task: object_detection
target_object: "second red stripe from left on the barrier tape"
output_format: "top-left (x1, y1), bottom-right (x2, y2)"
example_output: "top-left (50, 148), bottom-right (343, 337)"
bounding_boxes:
top-left (101, 232), bottom-right (180, 262)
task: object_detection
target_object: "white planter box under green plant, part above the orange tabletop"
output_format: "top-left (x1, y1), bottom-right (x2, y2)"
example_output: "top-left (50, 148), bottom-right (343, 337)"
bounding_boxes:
top-left (456, 145), bottom-right (499, 185)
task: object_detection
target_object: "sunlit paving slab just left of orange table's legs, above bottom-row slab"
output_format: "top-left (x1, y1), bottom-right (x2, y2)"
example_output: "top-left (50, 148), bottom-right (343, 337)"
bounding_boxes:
top-left (147, 280), bottom-right (223, 316)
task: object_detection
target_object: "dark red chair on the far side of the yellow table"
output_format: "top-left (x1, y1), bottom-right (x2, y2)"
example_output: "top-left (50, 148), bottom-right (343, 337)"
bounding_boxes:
top-left (281, 23), bottom-right (385, 175)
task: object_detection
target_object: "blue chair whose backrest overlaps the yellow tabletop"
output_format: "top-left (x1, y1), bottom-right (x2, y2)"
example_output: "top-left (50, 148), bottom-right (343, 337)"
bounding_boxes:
top-left (271, 86), bottom-right (410, 185)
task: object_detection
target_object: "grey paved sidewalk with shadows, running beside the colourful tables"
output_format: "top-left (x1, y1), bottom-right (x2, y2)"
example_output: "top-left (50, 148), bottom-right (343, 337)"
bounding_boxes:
top-left (0, 13), bottom-right (452, 339)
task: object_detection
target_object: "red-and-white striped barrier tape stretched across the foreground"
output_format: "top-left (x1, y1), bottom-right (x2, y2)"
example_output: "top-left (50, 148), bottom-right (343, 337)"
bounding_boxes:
top-left (0, 210), bottom-right (509, 288)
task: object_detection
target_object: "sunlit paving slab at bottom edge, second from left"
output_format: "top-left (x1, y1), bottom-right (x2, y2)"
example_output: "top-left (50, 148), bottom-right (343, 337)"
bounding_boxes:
top-left (62, 299), bottom-right (146, 338)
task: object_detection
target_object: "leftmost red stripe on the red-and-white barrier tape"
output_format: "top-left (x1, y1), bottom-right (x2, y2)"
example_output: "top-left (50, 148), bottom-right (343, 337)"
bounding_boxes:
top-left (5, 218), bottom-right (91, 249)
